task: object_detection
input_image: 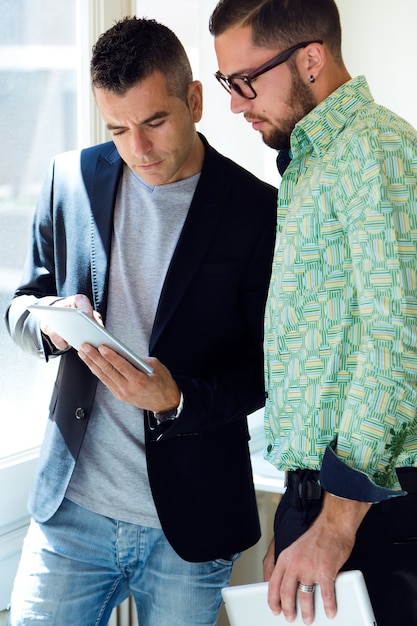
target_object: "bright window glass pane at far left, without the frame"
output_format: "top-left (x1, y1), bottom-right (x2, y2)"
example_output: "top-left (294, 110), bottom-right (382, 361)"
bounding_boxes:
top-left (0, 0), bottom-right (77, 458)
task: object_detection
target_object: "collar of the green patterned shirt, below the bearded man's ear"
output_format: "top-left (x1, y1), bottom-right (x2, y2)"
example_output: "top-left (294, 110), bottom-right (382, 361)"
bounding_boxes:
top-left (291, 76), bottom-right (374, 156)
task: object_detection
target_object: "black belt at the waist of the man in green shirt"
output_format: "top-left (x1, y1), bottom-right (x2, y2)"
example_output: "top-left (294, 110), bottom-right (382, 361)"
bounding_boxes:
top-left (285, 467), bottom-right (417, 500)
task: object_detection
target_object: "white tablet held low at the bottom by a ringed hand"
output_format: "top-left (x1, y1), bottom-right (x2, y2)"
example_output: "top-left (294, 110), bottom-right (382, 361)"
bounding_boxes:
top-left (222, 570), bottom-right (376, 626)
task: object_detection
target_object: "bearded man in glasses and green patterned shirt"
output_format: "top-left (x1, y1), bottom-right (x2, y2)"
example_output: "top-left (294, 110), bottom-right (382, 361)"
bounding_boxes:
top-left (210, 0), bottom-right (417, 626)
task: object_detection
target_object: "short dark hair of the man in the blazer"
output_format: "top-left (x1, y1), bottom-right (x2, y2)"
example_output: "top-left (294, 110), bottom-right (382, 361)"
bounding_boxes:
top-left (90, 17), bottom-right (193, 101)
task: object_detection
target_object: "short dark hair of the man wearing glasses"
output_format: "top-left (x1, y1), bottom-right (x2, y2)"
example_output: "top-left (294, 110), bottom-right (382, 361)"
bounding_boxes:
top-left (209, 0), bottom-right (342, 61)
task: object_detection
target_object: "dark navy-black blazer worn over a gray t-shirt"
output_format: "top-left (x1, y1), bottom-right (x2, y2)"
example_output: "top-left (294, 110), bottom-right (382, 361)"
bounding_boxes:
top-left (6, 133), bottom-right (277, 561)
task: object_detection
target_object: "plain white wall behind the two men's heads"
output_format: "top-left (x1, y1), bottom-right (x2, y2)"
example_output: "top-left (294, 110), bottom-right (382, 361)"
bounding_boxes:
top-left (137, 0), bottom-right (417, 184)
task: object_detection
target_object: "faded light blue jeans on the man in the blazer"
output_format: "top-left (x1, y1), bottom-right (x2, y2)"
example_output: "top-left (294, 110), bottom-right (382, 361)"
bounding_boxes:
top-left (10, 500), bottom-right (238, 626)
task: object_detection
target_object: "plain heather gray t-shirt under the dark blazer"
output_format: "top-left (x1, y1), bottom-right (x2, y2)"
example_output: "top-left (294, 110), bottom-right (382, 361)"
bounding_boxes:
top-left (66, 166), bottom-right (199, 528)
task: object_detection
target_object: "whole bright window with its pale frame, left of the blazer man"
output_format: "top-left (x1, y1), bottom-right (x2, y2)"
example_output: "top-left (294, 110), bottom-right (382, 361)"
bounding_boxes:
top-left (0, 0), bottom-right (132, 611)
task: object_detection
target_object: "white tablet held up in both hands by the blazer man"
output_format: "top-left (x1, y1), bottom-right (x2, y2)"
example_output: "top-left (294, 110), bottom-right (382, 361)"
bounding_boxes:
top-left (28, 304), bottom-right (153, 374)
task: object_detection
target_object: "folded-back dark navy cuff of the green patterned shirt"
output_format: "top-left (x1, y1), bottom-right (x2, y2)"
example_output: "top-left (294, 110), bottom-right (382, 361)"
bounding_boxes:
top-left (320, 447), bottom-right (407, 503)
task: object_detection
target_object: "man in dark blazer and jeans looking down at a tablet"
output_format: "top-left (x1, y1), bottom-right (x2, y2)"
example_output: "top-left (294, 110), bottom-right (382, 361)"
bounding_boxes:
top-left (6, 18), bottom-right (276, 626)
